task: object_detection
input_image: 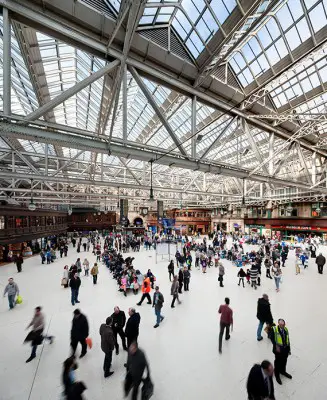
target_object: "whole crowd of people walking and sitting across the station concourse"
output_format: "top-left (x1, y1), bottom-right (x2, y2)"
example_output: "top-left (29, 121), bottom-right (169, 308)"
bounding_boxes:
top-left (4, 228), bottom-right (326, 400)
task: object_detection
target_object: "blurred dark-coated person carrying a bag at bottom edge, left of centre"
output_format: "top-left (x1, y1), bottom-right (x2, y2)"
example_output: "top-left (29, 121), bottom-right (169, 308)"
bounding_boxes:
top-left (125, 342), bottom-right (149, 400)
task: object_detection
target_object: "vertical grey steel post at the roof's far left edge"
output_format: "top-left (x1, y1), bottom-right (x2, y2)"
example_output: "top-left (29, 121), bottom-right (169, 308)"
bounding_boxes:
top-left (2, 8), bottom-right (11, 115)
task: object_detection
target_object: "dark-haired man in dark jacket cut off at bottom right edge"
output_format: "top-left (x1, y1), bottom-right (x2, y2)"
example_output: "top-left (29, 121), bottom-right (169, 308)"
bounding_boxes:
top-left (246, 360), bottom-right (275, 400)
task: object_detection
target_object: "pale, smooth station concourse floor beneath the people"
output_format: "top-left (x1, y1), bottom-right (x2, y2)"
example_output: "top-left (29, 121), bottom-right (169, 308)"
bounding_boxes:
top-left (0, 239), bottom-right (327, 400)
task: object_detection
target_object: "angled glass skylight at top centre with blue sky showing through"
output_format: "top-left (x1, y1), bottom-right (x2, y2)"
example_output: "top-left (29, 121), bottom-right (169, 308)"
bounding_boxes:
top-left (140, 0), bottom-right (237, 58)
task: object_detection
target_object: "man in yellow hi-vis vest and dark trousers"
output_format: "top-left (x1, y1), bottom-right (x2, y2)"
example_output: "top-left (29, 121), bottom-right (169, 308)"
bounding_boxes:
top-left (271, 319), bottom-right (292, 385)
